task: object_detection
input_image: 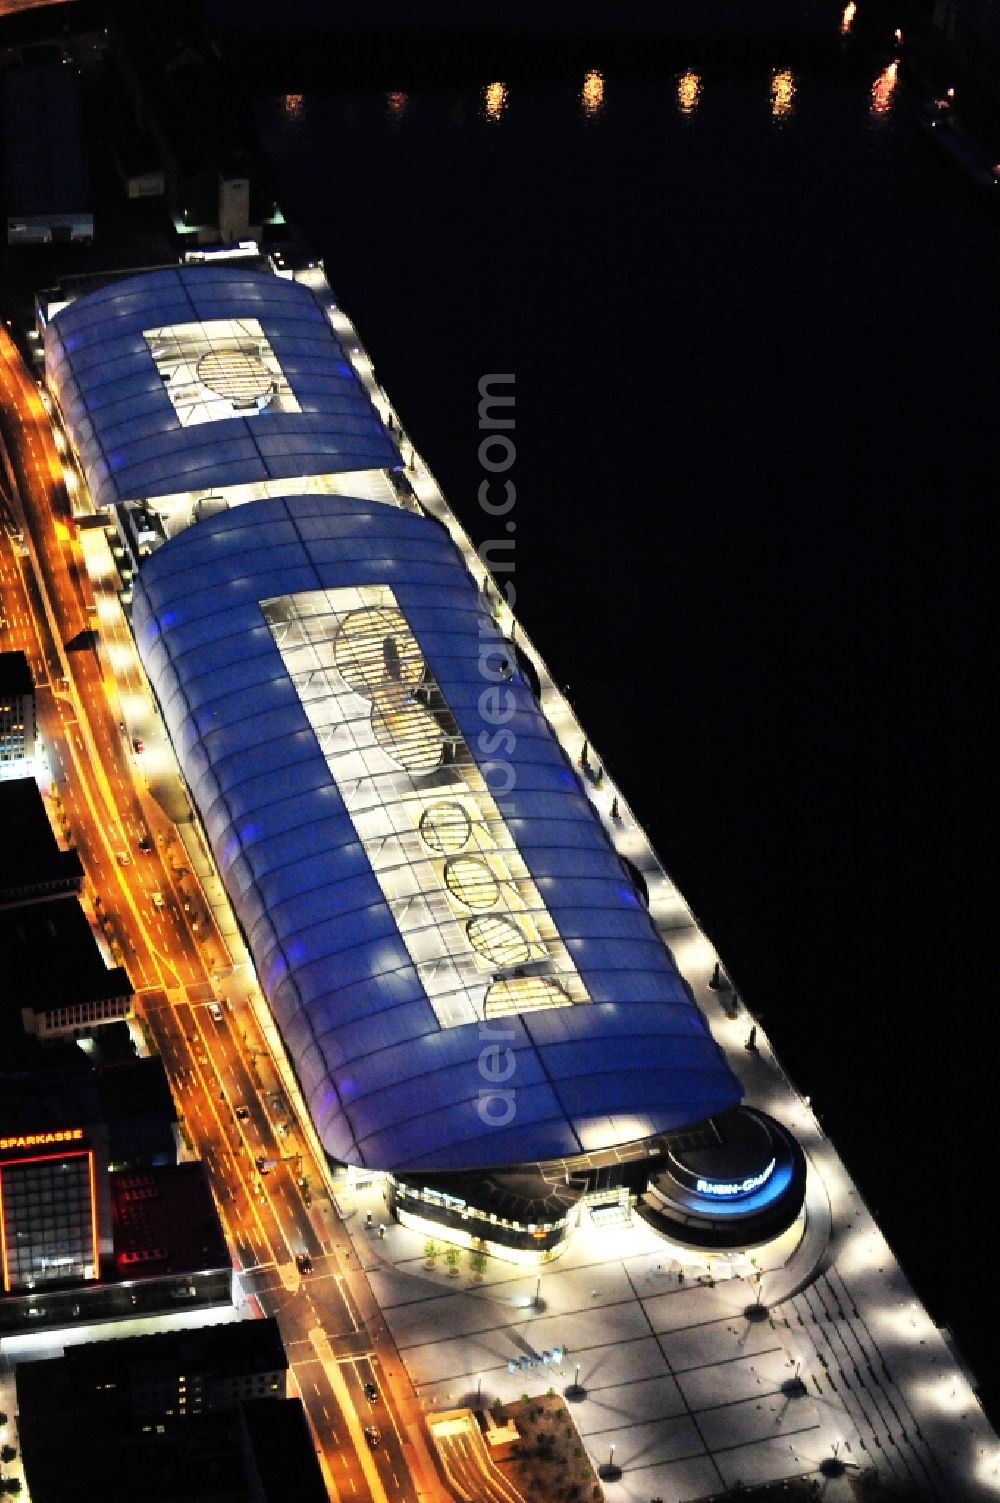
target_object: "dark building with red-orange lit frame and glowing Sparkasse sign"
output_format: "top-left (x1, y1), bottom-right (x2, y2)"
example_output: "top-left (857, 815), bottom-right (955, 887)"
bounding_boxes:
top-left (0, 1058), bottom-right (232, 1332)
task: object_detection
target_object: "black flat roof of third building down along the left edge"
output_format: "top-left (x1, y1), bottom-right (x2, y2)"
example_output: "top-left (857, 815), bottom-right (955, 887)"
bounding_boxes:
top-left (0, 897), bottom-right (132, 1013)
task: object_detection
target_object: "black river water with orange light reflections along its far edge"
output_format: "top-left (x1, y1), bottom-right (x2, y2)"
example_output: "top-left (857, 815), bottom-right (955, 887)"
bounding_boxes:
top-left (260, 14), bottom-right (1000, 1407)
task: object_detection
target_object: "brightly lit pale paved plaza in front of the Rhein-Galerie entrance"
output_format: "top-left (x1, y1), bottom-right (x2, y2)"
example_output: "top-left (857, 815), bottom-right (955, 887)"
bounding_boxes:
top-left (341, 1160), bottom-right (1000, 1503)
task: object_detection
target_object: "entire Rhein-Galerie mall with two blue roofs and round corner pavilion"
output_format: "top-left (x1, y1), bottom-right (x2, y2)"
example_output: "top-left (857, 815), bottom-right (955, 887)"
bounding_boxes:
top-left (39, 260), bottom-right (805, 1260)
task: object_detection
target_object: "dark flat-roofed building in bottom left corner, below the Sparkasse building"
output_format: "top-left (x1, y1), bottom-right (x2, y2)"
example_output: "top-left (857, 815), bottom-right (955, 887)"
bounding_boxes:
top-left (17, 1320), bottom-right (328, 1503)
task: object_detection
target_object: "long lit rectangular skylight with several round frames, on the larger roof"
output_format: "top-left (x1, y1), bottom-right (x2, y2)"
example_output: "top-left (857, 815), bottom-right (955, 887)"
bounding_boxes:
top-left (260, 585), bottom-right (588, 1028)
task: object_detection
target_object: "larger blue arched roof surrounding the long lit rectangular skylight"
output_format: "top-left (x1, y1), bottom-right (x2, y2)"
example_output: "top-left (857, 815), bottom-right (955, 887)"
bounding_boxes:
top-left (132, 496), bottom-right (741, 1171)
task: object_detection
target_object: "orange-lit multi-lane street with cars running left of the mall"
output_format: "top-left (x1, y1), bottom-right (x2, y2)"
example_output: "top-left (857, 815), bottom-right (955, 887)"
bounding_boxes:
top-left (0, 331), bottom-right (430, 1503)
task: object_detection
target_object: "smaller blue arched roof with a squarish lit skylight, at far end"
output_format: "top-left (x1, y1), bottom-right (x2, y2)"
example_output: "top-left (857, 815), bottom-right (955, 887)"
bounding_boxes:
top-left (45, 263), bottom-right (398, 507)
